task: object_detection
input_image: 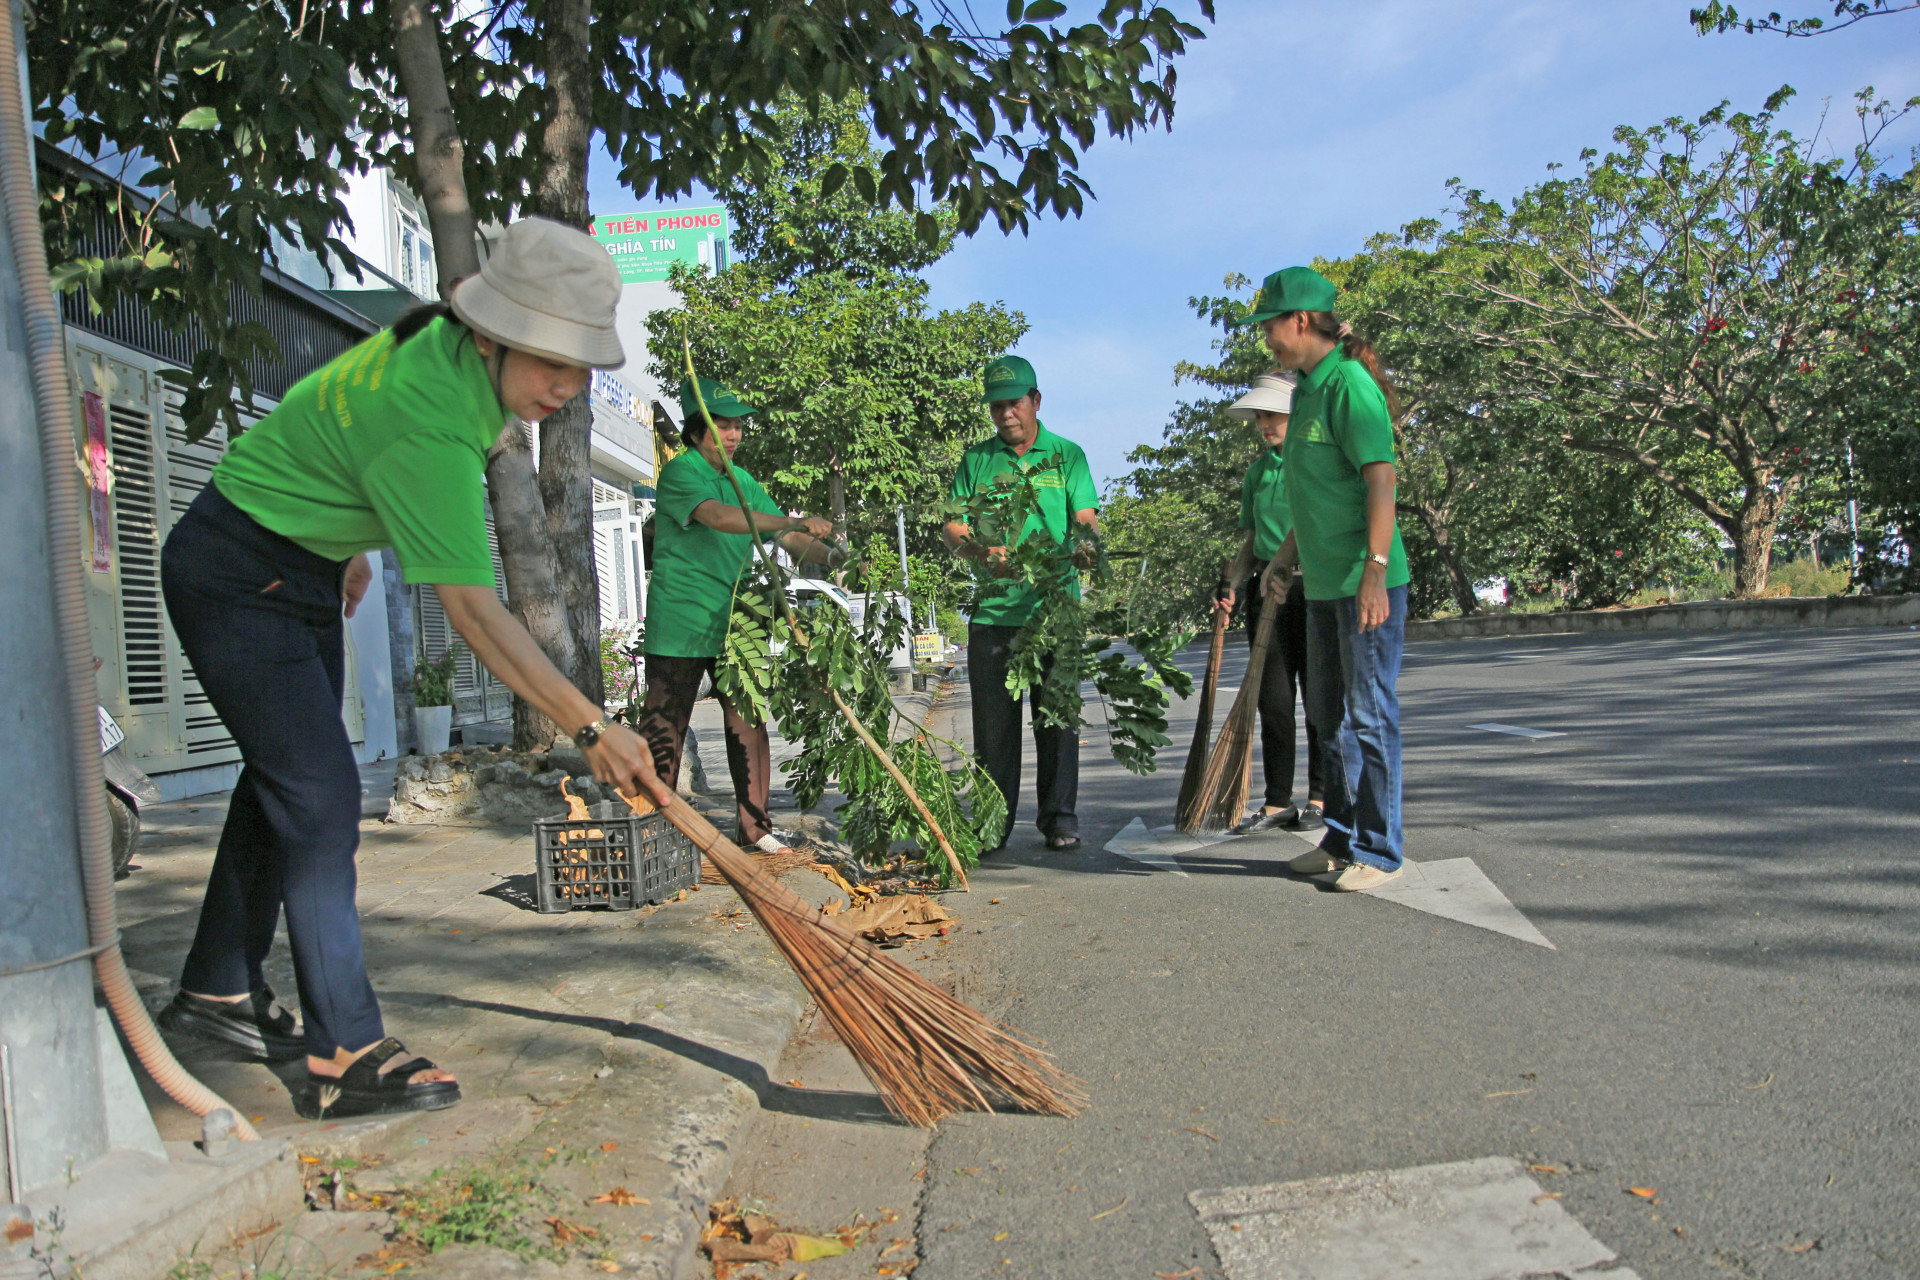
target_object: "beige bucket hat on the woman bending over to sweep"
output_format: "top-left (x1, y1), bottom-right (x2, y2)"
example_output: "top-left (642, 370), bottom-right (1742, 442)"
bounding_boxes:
top-left (447, 217), bottom-right (626, 368)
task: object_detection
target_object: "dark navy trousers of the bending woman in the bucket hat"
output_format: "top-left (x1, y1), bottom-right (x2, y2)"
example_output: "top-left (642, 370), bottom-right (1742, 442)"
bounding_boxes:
top-left (161, 484), bottom-right (386, 1057)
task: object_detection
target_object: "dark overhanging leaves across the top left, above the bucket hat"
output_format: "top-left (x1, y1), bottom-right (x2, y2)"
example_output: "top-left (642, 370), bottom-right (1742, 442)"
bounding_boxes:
top-left (29, 0), bottom-right (1212, 432)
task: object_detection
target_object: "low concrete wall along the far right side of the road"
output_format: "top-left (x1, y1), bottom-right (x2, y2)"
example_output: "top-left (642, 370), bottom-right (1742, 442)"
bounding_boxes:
top-left (1407, 595), bottom-right (1920, 641)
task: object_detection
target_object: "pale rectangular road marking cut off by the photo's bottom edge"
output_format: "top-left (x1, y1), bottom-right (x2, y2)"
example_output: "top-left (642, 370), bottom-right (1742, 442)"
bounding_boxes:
top-left (1187, 1155), bottom-right (1638, 1280)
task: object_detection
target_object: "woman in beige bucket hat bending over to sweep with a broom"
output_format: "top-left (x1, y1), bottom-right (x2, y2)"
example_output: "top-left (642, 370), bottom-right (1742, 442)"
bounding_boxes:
top-left (161, 219), bottom-right (674, 1119)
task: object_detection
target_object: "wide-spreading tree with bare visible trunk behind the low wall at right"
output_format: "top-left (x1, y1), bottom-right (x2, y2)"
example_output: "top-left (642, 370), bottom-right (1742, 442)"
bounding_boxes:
top-left (1413, 90), bottom-right (1901, 597)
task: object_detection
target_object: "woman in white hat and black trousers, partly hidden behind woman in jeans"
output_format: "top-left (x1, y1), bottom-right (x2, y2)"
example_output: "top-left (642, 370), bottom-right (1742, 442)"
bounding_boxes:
top-left (1215, 370), bottom-right (1327, 835)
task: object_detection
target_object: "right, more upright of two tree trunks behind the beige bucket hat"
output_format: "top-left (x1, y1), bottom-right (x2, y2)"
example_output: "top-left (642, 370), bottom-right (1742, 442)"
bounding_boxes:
top-left (528, 0), bottom-right (607, 702)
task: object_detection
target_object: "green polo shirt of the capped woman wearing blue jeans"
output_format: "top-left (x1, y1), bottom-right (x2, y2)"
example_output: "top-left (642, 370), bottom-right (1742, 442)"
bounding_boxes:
top-left (1283, 347), bottom-right (1409, 601)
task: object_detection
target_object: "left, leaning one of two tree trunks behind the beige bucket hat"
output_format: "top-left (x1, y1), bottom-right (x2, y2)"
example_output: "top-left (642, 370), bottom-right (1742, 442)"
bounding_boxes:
top-left (394, 0), bottom-right (576, 750)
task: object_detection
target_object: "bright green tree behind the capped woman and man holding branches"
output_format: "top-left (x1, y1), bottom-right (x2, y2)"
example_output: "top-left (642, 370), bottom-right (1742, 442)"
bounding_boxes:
top-left (649, 100), bottom-right (1027, 625)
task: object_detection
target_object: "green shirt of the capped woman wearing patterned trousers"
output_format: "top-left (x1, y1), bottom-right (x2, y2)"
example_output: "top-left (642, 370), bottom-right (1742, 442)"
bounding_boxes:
top-left (647, 449), bottom-right (783, 658)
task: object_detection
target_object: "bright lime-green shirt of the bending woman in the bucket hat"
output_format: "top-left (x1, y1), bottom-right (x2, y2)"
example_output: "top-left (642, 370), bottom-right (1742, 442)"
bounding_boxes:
top-left (213, 317), bottom-right (507, 587)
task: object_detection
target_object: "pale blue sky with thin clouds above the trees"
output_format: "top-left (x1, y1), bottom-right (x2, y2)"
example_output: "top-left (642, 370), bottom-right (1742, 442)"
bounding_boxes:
top-left (593, 0), bottom-right (1920, 480)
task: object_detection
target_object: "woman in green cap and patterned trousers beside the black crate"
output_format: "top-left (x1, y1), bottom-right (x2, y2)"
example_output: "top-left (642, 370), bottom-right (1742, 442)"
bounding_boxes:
top-left (639, 378), bottom-right (833, 854)
